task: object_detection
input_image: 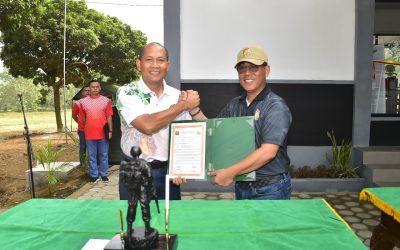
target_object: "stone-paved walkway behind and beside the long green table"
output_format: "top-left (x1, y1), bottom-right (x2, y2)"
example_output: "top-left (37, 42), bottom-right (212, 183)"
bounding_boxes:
top-left (68, 166), bottom-right (399, 250)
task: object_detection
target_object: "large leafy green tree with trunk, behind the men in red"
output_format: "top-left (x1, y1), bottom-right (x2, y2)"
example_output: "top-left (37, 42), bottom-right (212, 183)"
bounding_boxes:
top-left (0, 0), bottom-right (146, 130)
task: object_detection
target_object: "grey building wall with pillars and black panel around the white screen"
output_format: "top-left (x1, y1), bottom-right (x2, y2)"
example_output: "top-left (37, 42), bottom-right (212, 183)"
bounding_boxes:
top-left (164, 0), bottom-right (375, 166)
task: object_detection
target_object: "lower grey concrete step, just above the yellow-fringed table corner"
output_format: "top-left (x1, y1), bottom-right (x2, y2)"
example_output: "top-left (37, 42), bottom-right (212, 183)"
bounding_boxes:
top-left (359, 164), bottom-right (400, 183)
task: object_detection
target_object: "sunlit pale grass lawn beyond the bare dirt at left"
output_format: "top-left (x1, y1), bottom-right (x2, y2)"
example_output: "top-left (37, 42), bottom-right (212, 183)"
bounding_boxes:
top-left (0, 109), bottom-right (77, 138)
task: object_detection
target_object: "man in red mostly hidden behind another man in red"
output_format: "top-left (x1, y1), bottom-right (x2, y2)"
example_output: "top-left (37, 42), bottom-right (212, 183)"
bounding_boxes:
top-left (72, 86), bottom-right (90, 166)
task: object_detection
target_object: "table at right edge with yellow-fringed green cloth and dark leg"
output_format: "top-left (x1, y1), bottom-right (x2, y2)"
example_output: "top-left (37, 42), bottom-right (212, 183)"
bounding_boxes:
top-left (360, 187), bottom-right (400, 249)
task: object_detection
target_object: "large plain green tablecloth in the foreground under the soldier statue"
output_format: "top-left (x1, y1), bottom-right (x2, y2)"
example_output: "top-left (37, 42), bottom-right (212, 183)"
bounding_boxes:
top-left (0, 199), bottom-right (366, 250)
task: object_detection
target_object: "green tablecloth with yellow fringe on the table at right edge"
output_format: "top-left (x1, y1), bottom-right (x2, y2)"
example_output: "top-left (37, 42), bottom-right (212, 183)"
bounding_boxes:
top-left (360, 187), bottom-right (400, 222)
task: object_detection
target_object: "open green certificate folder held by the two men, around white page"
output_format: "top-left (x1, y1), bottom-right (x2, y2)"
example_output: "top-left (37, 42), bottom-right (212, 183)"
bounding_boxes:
top-left (169, 116), bottom-right (256, 181)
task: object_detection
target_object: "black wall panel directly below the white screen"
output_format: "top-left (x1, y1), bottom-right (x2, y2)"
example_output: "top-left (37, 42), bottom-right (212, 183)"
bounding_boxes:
top-left (182, 83), bottom-right (353, 146)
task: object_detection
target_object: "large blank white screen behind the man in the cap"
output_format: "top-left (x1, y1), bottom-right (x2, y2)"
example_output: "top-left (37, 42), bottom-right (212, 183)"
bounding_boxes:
top-left (180, 0), bottom-right (355, 80)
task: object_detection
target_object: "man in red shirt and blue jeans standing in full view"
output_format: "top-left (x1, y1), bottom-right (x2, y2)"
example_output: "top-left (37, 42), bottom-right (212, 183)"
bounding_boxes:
top-left (80, 80), bottom-right (113, 183)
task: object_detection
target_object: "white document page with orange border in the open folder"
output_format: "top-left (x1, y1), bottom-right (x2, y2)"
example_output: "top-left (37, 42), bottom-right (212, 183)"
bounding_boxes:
top-left (169, 122), bottom-right (206, 179)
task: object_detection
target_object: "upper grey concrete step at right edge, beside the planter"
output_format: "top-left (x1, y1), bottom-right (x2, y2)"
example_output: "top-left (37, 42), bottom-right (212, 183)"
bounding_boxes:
top-left (354, 146), bottom-right (400, 166)
